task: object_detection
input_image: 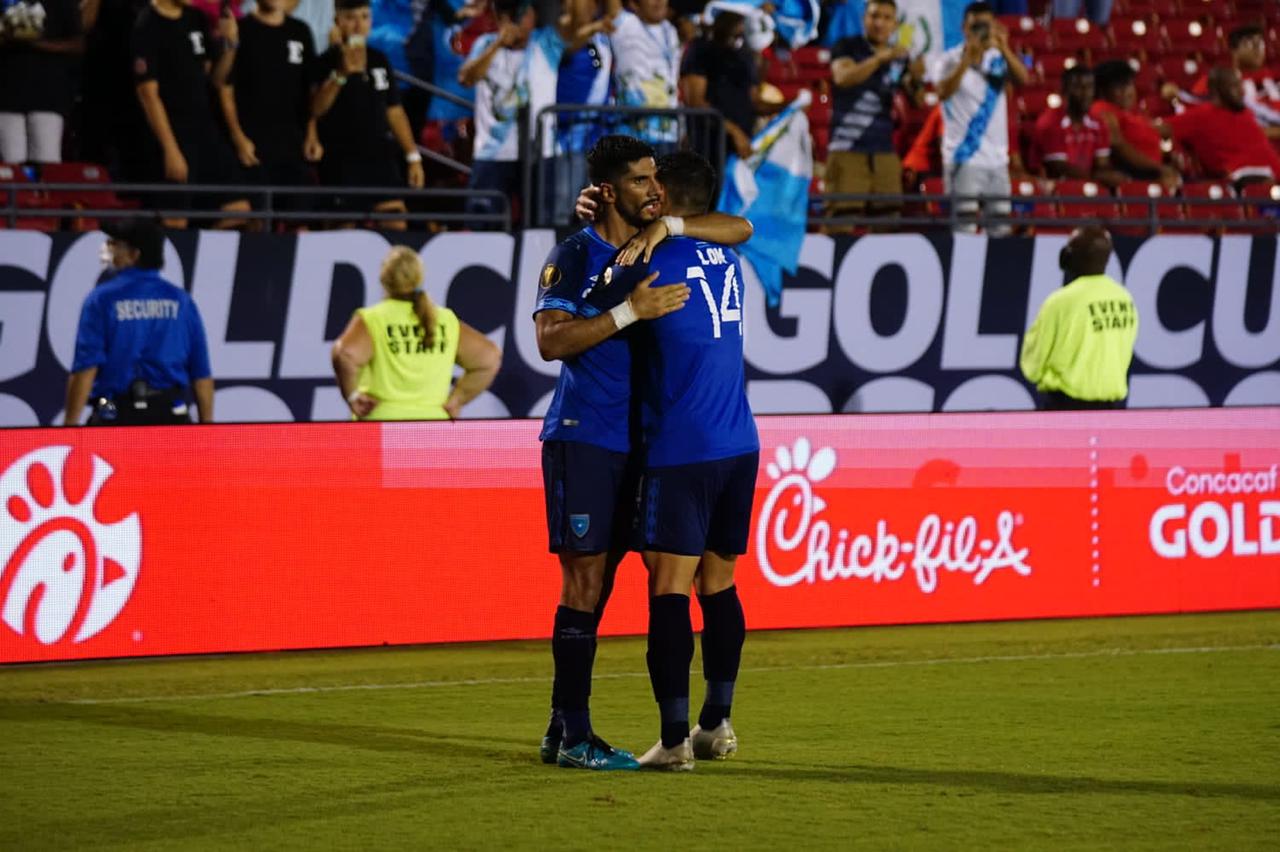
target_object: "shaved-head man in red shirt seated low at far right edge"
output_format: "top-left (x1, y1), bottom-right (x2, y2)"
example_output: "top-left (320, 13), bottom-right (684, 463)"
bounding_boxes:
top-left (1164, 65), bottom-right (1280, 189)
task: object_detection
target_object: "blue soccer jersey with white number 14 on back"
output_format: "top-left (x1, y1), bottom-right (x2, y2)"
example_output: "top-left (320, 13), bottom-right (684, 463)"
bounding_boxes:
top-left (628, 237), bottom-right (760, 467)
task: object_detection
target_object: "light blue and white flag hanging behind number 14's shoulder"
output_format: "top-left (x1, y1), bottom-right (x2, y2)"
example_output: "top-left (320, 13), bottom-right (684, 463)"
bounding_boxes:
top-left (718, 91), bottom-right (813, 306)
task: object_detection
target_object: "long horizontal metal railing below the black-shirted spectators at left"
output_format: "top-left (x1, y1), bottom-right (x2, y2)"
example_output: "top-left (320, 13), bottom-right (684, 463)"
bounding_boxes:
top-left (0, 183), bottom-right (511, 232)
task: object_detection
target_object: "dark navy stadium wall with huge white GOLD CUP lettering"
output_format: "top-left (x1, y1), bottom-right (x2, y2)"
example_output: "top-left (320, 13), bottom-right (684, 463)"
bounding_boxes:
top-left (0, 230), bottom-right (1280, 426)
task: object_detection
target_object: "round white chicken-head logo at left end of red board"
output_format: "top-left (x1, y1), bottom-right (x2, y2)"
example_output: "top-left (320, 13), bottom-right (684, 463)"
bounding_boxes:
top-left (0, 446), bottom-right (142, 645)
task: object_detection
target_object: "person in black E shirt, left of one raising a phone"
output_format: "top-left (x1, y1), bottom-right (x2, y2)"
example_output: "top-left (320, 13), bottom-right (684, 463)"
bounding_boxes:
top-left (219, 0), bottom-right (323, 209)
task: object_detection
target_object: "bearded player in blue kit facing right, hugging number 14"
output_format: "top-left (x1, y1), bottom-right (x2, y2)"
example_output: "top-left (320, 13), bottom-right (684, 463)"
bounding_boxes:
top-left (535, 136), bottom-right (750, 769)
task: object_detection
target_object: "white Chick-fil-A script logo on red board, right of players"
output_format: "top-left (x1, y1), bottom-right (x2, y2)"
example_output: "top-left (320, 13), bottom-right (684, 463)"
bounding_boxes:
top-left (755, 438), bottom-right (1032, 595)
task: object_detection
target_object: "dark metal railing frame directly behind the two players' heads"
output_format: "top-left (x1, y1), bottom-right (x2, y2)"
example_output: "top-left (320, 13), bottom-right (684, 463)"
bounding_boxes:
top-left (521, 104), bottom-right (727, 228)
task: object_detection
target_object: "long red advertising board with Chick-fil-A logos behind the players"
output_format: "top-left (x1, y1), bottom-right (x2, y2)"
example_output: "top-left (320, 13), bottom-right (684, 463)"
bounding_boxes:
top-left (0, 408), bottom-right (1280, 663)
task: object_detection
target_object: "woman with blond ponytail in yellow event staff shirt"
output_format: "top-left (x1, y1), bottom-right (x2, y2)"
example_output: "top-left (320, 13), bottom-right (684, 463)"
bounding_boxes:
top-left (333, 246), bottom-right (502, 420)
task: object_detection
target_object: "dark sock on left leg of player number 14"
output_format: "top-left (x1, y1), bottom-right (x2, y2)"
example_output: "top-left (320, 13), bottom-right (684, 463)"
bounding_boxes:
top-left (645, 595), bottom-right (694, 748)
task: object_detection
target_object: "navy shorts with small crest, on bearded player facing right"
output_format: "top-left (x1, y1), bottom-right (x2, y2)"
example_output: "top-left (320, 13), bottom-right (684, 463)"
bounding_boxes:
top-left (543, 441), bottom-right (641, 553)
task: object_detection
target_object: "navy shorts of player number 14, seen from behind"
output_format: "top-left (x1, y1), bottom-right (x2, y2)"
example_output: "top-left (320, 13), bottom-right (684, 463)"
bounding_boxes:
top-left (640, 453), bottom-right (760, 556)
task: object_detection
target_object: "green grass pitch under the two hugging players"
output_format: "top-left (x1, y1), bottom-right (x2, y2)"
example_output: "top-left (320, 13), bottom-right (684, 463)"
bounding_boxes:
top-left (0, 611), bottom-right (1280, 851)
